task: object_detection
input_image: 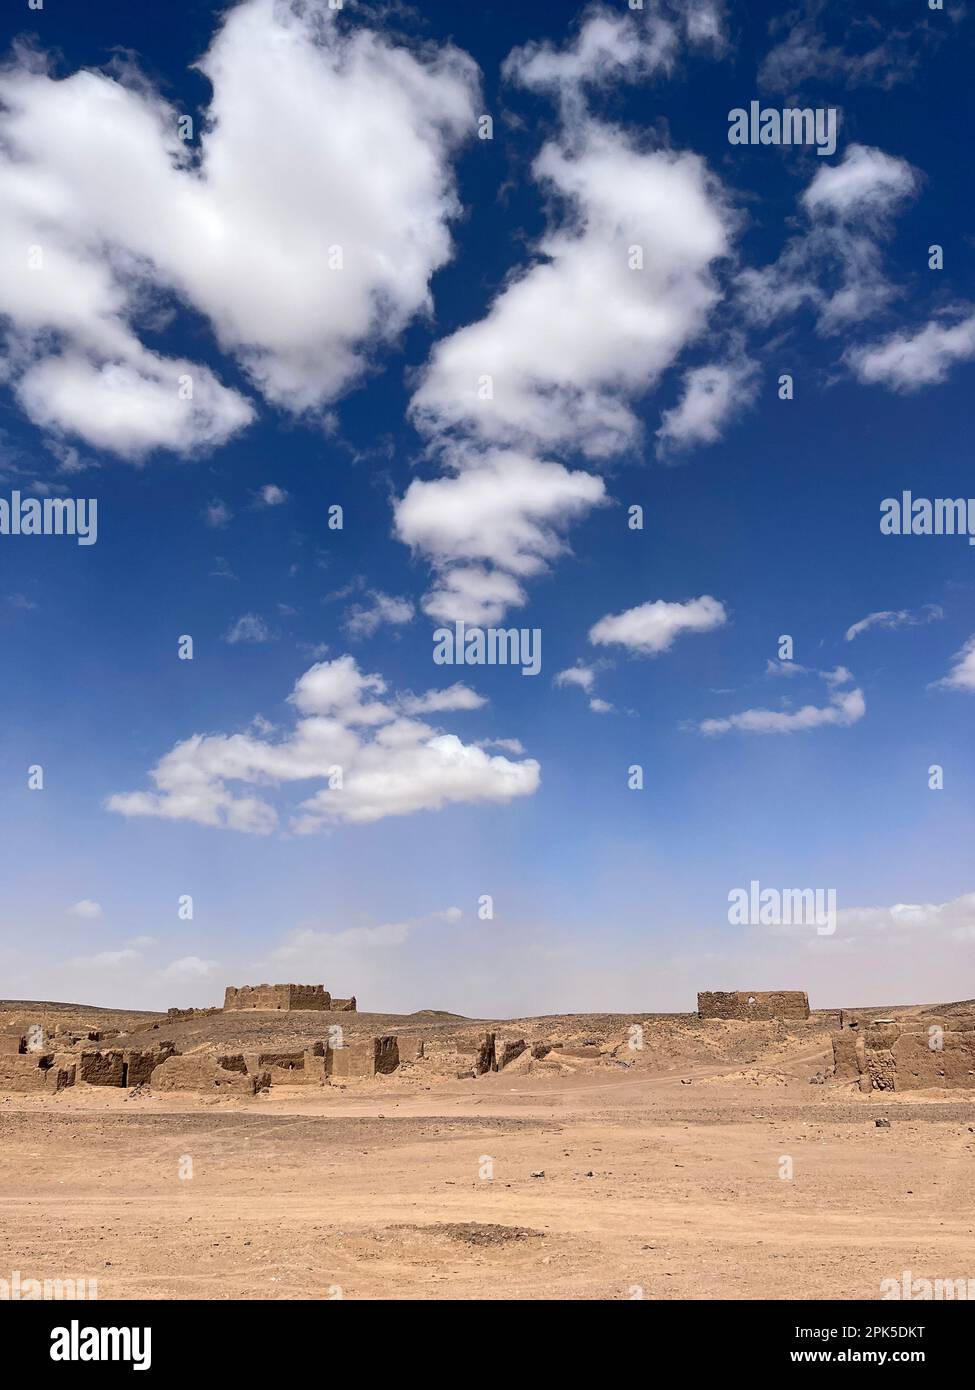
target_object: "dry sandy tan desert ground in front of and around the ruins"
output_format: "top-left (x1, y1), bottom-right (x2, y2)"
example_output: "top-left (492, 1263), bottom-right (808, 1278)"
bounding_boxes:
top-left (0, 1002), bottom-right (975, 1300)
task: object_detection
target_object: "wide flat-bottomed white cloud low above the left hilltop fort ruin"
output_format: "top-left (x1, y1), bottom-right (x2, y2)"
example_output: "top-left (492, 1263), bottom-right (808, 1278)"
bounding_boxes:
top-left (107, 656), bottom-right (540, 834)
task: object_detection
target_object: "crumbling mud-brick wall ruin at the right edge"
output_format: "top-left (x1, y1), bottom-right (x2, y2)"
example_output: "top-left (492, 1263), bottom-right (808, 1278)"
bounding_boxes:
top-left (833, 1015), bottom-right (975, 1093)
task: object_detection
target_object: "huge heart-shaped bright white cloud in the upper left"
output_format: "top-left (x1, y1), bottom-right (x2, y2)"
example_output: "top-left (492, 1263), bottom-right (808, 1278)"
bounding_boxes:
top-left (0, 0), bottom-right (477, 459)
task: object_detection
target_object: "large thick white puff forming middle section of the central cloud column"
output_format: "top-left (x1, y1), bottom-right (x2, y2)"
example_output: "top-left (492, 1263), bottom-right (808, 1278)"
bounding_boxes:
top-left (412, 120), bottom-right (732, 459)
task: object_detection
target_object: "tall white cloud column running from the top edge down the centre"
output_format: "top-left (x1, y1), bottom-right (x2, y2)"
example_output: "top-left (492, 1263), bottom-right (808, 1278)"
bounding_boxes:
top-left (396, 13), bottom-right (736, 624)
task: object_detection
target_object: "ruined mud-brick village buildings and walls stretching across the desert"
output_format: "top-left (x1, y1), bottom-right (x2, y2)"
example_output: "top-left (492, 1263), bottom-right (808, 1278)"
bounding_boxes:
top-left (0, 984), bottom-right (975, 1097)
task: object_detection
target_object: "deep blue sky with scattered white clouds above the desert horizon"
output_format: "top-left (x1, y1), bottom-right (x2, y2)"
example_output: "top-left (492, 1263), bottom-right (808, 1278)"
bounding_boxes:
top-left (0, 0), bottom-right (975, 1016)
